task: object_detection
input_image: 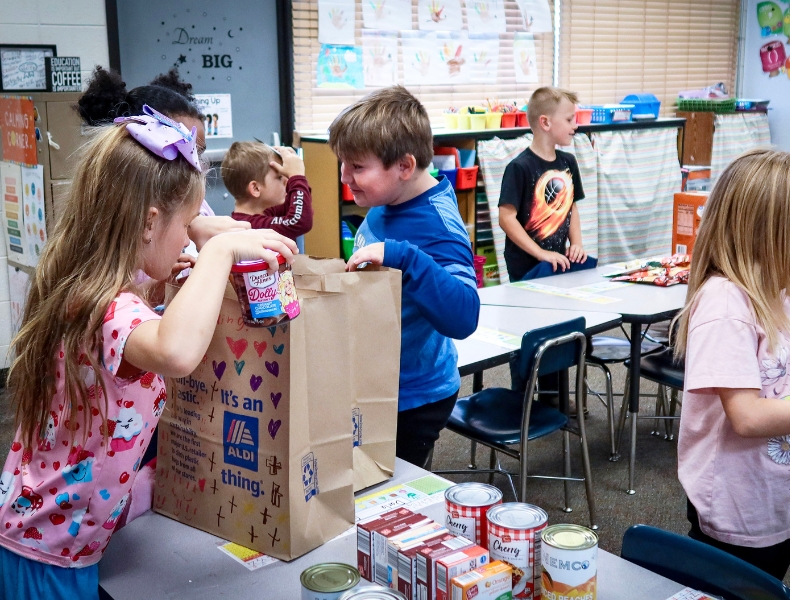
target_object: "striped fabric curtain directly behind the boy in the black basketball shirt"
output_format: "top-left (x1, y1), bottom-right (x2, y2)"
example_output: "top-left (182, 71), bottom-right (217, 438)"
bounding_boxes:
top-left (477, 133), bottom-right (598, 283)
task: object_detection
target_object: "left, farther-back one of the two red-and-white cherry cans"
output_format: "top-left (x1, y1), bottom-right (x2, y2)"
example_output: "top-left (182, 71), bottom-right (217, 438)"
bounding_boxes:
top-left (444, 482), bottom-right (502, 548)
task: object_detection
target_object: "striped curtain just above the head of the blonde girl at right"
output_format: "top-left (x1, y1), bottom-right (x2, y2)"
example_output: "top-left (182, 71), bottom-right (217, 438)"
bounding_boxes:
top-left (711, 113), bottom-right (771, 181)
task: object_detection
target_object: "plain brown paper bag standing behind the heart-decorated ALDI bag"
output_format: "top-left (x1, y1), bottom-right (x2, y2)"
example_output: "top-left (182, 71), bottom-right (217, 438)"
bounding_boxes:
top-left (293, 257), bottom-right (401, 492)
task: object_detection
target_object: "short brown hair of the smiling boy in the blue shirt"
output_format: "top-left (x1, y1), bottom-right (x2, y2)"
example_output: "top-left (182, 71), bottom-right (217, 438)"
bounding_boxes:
top-left (329, 85), bottom-right (433, 169)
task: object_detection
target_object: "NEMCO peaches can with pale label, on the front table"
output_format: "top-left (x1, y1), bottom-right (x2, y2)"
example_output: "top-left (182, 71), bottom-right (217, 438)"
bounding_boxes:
top-left (541, 524), bottom-right (598, 600)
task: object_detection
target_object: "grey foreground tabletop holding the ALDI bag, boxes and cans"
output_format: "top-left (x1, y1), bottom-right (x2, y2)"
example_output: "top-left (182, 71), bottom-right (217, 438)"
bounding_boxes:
top-left (99, 459), bottom-right (684, 600)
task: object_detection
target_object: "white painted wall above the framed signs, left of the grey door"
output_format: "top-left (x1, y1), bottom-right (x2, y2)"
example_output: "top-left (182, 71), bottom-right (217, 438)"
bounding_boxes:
top-left (0, 0), bottom-right (110, 84)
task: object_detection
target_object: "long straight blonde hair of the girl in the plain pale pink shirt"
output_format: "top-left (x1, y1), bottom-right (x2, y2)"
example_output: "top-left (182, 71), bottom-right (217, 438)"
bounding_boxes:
top-left (675, 149), bottom-right (790, 357)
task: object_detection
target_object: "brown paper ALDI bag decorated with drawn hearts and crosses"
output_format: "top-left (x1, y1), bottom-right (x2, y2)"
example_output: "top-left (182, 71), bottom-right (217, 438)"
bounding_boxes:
top-left (154, 278), bottom-right (354, 560)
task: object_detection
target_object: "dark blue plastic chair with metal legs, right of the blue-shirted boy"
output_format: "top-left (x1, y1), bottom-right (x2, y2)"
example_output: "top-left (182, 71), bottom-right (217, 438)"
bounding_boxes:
top-left (435, 317), bottom-right (597, 529)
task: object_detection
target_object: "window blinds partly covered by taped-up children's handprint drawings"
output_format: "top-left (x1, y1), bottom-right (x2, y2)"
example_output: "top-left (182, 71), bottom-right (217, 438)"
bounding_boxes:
top-left (292, 0), bottom-right (554, 134)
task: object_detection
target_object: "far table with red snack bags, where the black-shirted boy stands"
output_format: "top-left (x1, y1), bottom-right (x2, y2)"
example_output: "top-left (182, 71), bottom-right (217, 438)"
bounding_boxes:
top-left (478, 265), bottom-right (688, 494)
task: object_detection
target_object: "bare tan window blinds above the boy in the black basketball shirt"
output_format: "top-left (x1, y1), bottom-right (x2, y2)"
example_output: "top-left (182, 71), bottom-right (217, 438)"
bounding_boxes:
top-left (560, 0), bottom-right (740, 116)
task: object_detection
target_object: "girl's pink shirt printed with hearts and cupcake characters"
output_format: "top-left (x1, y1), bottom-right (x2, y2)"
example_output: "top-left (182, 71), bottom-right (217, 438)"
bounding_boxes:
top-left (0, 292), bottom-right (167, 567)
